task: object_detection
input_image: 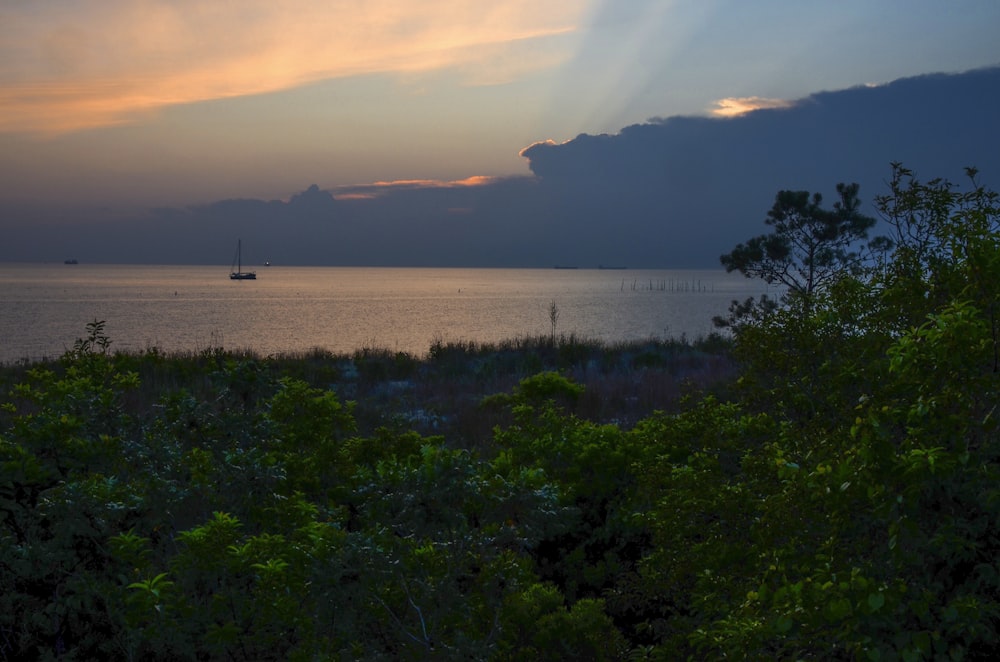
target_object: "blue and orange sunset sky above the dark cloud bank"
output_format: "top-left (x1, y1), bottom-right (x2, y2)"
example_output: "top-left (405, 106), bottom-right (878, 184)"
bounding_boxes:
top-left (0, 0), bottom-right (1000, 262)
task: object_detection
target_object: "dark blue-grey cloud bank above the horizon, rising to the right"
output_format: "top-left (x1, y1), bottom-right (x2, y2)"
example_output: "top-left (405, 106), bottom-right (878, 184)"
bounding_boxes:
top-left (9, 68), bottom-right (1000, 267)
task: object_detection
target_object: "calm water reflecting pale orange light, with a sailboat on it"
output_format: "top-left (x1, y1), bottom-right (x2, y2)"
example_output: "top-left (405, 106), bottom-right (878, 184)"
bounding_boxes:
top-left (0, 264), bottom-right (766, 363)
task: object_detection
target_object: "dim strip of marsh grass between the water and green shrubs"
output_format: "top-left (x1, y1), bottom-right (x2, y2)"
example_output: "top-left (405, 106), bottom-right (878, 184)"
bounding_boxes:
top-left (0, 334), bottom-right (734, 448)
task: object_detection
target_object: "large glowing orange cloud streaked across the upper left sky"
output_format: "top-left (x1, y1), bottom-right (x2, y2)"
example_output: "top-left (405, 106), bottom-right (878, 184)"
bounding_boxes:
top-left (0, 0), bottom-right (589, 134)
